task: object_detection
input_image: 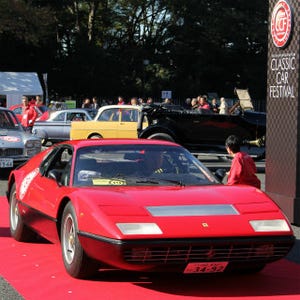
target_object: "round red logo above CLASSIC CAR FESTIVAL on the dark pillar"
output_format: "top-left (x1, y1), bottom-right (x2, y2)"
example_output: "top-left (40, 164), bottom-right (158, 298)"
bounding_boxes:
top-left (271, 0), bottom-right (292, 48)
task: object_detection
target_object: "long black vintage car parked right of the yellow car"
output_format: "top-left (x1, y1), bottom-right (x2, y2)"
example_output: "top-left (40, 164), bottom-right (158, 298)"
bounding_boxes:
top-left (138, 104), bottom-right (266, 159)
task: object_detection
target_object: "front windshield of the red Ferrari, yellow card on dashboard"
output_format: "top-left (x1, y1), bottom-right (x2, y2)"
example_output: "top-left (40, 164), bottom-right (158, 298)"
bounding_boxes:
top-left (73, 144), bottom-right (218, 186)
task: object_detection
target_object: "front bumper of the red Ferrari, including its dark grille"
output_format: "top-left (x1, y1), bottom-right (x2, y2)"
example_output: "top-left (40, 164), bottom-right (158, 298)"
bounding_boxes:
top-left (79, 232), bottom-right (295, 271)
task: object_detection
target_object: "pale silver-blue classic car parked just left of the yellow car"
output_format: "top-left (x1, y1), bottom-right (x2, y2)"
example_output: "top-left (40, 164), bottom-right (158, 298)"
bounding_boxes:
top-left (32, 108), bottom-right (92, 145)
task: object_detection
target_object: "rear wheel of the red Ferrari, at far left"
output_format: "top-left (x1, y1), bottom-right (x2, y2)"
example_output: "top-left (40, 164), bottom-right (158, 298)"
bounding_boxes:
top-left (9, 183), bottom-right (36, 242)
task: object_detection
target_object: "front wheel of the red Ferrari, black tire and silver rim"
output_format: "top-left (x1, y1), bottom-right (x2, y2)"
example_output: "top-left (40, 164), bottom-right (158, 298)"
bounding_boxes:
top-left (61, 202), bottom-right (99, 279)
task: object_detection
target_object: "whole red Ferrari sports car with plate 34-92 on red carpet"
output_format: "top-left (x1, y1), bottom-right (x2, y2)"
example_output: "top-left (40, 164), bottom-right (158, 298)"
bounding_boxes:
top-left (7, 139), bottom-right (294, 278)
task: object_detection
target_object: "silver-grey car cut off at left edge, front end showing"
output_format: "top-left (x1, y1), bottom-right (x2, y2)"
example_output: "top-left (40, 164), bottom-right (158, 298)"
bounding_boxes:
top-left (0, 108), bottom-right (42, 169)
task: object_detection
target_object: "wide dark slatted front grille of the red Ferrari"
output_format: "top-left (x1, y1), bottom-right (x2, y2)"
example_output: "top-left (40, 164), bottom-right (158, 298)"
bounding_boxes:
top-left (123, 243), bottom-right (291, 264)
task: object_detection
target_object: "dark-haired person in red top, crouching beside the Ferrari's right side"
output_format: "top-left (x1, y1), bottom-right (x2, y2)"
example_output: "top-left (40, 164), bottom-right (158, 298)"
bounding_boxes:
top-left (225, 135), bottom-right (260, 189)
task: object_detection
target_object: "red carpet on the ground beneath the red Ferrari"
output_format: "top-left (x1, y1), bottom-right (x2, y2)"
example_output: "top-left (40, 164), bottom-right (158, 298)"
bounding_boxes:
top-left (0, 197), bottom-right (300, 300)
